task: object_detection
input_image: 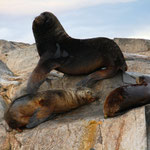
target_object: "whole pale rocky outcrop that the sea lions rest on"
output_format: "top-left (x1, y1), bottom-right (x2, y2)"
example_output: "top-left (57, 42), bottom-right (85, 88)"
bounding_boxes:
top-left (0, 39), bottom-right (150, 150)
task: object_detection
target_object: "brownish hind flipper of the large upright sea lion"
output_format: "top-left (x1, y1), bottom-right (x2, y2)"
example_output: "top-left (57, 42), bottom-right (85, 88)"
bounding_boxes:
top-left (77, 66), bottom-right (117, 87)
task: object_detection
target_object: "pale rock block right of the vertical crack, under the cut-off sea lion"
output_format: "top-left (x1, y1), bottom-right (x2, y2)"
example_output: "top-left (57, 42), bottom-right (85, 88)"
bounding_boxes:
top-left (101, 107), bottom-right (147, 150)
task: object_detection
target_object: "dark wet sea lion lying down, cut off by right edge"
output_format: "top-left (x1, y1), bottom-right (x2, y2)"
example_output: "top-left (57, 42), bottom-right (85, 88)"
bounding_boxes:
top-left (103, 80), bottom-right (150, 118)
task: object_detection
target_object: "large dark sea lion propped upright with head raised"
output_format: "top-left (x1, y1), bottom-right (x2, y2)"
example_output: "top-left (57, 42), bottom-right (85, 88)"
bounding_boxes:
top-left (27, 12), bottom-right (127, 93)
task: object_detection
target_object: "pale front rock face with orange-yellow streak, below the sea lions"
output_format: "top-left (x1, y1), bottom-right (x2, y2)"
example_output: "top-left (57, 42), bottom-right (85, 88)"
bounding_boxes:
top-left (11, 108), bottom-right (147, 150)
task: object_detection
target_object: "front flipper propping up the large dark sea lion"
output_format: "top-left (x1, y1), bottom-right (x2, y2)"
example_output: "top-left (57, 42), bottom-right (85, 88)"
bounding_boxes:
top-left (26, 58), bottom-right (60, 93)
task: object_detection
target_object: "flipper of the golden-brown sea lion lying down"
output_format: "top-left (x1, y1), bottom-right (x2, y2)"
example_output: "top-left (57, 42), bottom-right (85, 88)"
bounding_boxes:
top-left (26, 108), bottom-right (56, 129)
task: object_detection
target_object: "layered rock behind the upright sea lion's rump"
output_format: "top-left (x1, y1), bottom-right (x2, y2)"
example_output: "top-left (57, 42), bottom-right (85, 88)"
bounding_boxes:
top-left (114, 38), bottom-right (150, 74)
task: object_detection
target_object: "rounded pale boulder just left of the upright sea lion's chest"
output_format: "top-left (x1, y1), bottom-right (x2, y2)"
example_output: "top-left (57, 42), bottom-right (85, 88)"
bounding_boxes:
top-left (4, 45), bottom-right (39, 75)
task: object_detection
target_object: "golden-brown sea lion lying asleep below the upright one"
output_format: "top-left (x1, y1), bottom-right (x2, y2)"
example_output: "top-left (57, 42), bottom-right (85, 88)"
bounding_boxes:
top-left (4, 89), bottom-right (98, 129)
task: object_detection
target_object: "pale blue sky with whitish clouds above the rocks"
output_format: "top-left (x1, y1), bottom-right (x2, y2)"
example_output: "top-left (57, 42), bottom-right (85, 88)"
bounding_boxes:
top-left (0, 0), bottom-right (150, 43)
